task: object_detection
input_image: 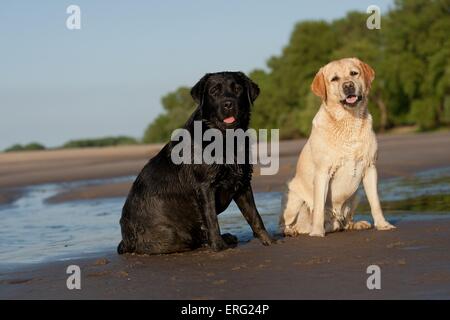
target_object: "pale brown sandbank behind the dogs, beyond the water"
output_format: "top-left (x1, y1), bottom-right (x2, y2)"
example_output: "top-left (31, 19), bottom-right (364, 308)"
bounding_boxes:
top-left (0, 132), bottom-right (450, 204)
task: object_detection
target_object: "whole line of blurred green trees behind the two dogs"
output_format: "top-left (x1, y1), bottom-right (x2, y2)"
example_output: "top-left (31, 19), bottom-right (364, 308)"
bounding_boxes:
top-left (143, 0), bottom-right (450, 143)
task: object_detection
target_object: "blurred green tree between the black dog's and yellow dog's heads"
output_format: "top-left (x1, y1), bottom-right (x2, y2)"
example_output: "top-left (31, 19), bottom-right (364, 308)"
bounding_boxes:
top-left (250, 21), bottom-right (337, 139)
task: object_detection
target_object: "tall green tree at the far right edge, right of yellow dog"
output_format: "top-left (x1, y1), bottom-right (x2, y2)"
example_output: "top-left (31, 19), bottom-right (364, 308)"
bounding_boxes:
top-left (385, 0), bottom-right (450, 130)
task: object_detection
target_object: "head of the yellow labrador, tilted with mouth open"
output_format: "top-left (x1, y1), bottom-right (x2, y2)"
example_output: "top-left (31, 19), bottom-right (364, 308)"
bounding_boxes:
top-left (311, 58), bottom-right (375, 109)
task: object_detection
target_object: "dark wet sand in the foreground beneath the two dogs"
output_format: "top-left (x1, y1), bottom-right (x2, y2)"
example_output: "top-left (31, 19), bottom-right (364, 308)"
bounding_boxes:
top-left (0, 219), bottom-right (450, 299)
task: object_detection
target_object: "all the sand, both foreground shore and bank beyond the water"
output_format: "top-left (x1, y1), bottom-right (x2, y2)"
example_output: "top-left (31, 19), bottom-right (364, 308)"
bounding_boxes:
top-left (0, 132), bottom-right (450, 299)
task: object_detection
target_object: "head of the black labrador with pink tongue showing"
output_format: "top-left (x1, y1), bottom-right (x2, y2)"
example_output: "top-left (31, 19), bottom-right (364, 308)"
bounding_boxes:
top-left (191, 72), bottom-right (259, 130)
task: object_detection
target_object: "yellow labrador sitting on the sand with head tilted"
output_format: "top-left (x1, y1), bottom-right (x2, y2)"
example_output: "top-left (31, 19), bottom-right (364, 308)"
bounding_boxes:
top-left (280, 58), bottom-right (395, 237)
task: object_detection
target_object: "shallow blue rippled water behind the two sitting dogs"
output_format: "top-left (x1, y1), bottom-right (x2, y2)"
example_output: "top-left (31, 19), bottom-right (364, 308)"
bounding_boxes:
top-left (0, 167), bottom-right (450, 269)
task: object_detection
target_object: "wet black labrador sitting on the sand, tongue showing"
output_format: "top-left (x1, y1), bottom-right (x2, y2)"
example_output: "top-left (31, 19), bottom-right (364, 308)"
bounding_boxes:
top-left (117, 72), bottom-right (273, 254)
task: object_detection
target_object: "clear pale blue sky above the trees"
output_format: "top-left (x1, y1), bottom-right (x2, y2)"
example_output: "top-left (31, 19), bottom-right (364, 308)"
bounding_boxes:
top-left (0, 0), bottom-right (392, 149)
